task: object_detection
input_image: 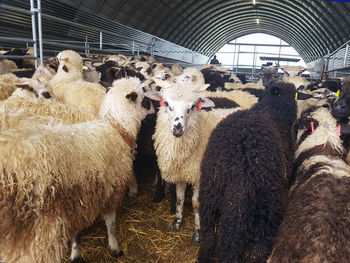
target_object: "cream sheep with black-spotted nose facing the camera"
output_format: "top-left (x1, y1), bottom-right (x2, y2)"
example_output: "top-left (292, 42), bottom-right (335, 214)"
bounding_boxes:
top-left (145, 79), bottom-right (240, 243)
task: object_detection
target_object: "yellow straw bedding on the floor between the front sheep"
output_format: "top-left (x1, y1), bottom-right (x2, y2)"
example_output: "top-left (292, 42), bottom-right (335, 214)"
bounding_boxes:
top-left (63, 175), bottom-right (199, 263)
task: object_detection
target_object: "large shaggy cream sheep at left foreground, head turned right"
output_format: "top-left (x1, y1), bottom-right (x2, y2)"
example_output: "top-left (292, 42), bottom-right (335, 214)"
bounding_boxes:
top-left (0, 78), bottom-right (154, 263)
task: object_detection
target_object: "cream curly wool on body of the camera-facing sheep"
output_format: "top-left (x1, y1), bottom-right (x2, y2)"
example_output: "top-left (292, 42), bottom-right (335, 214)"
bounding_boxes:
top-left (153, 107), bottom-right (240, 185)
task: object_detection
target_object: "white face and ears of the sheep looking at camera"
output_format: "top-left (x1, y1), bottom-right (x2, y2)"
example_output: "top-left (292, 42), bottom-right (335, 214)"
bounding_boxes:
top-left (145, 81), bottom-right (214, 137)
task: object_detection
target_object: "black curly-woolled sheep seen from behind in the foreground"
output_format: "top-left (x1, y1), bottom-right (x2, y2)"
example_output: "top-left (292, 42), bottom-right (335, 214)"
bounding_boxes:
top-left (198, 82), bottom-right (296, 263)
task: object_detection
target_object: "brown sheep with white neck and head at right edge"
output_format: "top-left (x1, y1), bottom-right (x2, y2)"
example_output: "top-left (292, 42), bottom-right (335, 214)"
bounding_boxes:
top-left (268, 107), bottom-right (350, 263)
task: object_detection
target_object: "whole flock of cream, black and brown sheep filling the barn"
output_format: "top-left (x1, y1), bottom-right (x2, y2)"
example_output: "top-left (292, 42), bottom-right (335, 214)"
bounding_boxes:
top-left (0, 50), bottom-right (350, 263)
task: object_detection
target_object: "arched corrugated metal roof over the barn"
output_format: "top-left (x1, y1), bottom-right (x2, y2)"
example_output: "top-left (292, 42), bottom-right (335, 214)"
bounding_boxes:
top-left (4, 0), bottom-right (350, 62)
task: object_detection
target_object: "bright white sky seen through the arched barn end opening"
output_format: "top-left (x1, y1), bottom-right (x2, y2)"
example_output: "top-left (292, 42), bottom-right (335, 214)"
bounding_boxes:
top-left (216, 33), bottom-right (306, 68)
